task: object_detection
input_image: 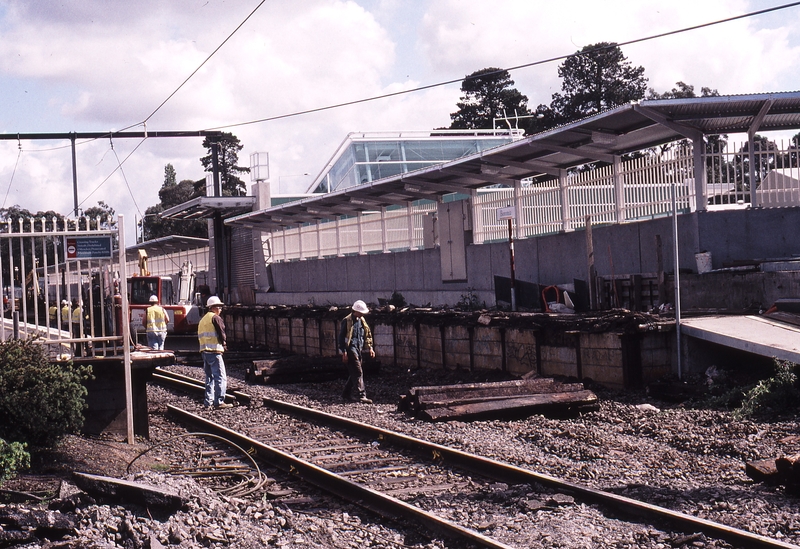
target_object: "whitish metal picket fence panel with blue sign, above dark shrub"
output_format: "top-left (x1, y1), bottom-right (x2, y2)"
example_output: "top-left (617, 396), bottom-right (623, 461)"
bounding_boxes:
top-left (0, 216), bottom-right (127, 360)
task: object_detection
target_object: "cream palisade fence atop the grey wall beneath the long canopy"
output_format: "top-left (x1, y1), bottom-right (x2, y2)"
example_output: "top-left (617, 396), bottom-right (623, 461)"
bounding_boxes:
top-left (262, 141), bottom-right (800, 261)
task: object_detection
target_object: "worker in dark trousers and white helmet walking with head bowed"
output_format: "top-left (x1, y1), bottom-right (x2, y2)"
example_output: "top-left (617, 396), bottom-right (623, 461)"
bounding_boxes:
top-left (338, 299), bottom-right (375, 404)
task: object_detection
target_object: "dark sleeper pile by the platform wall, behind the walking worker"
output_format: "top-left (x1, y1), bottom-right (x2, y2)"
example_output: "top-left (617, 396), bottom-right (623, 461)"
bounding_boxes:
top-left (245, 355), bottom-right (380, 385)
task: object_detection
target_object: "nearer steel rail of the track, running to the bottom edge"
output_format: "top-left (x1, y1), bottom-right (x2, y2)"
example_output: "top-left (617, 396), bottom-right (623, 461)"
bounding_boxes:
top-left (167, 405), bottom-right (513, 549)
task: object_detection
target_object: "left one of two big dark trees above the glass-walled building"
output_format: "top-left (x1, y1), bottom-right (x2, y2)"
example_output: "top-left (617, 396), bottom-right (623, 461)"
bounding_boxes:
top-left (450, 67), bottom-right (528, 130)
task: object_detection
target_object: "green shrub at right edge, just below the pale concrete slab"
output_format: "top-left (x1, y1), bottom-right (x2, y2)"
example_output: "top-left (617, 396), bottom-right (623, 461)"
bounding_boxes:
top-left (736, 360), bottom-right (800, 417)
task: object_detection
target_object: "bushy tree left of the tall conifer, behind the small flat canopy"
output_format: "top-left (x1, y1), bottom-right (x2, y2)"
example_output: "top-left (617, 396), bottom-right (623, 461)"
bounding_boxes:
top-left (142, 164), bottom-right (208, 240)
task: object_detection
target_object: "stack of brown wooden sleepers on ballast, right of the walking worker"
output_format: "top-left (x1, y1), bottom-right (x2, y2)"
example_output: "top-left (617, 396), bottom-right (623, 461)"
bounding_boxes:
top-left (398, 378), bottom-right (599, 421)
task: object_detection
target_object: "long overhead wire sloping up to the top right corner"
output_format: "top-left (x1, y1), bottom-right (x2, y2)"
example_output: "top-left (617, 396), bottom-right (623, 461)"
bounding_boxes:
top-left (204, 1), bottom-right (800, 131)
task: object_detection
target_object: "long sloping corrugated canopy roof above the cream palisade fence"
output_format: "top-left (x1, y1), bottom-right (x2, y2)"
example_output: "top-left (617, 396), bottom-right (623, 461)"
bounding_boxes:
top-left (225, 92), bottom-right (800, 230)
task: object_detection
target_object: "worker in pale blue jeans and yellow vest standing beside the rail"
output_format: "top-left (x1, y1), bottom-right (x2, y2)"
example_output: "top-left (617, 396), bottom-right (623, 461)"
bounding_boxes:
top-left (197, 295), bottom-right (233, 408)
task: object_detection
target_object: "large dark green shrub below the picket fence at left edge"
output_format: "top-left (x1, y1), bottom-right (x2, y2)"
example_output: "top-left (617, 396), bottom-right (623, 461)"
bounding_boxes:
top-left (0, 339), bottom-right (91, 448)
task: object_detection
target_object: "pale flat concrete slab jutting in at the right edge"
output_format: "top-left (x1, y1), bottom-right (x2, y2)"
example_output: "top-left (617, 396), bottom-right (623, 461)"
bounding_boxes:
top-left (681, 315), bottom-right (800, 363)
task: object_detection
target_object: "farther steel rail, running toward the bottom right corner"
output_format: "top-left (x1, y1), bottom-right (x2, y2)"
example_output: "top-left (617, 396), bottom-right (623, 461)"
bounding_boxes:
top-left (263, 398), bottom-right (800, 549)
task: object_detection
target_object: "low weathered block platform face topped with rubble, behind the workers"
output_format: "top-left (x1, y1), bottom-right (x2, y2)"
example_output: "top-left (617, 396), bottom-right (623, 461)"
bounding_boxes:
top-left (223, 307), bottom-right (675, 389)
